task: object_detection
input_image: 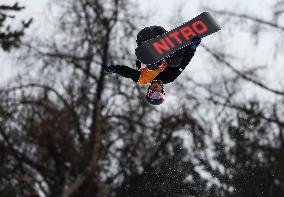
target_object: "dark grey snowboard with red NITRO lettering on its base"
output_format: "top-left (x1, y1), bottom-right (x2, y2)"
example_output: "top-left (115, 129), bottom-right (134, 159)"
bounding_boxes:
top-left (135, 12), bottom-right (221, 64)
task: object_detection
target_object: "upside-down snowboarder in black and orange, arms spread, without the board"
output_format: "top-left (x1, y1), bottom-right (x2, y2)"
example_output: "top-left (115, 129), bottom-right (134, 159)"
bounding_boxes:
top-left (103, 26), bottom-right (201, 105)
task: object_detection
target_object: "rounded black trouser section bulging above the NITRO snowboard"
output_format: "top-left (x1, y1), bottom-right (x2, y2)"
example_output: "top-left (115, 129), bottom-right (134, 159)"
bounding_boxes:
top-left (136, 26), bottom-right (167, 46)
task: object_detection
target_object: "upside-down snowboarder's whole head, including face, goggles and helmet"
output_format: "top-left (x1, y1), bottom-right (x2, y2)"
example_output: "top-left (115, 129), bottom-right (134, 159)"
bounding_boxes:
top-left (146, 80), bottom-right (166, 105)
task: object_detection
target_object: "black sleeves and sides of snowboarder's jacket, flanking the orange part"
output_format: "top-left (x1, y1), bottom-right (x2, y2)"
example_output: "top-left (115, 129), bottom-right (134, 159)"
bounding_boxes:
top-left (114, 47), bottom-right (195, 84)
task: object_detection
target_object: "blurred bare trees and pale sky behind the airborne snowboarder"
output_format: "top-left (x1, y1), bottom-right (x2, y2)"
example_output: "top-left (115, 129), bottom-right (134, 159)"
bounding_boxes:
top-left (0, 0), bottom-right (284, 197)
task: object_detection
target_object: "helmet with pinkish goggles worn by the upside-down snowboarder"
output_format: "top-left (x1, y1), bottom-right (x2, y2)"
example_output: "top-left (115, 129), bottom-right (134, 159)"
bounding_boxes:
top-left (146, 80), bottom-right (165, 105)
